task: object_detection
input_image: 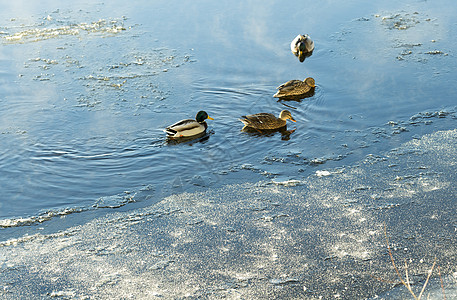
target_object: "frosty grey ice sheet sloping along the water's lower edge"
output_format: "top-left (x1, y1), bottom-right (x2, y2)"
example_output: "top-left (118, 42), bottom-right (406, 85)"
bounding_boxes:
top-left (0, 130), bottom-right (457, 299)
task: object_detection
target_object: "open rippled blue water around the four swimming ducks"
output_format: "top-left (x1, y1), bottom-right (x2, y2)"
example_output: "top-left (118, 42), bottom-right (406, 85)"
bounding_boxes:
top-left (0, 1), bottom-right (457, 224)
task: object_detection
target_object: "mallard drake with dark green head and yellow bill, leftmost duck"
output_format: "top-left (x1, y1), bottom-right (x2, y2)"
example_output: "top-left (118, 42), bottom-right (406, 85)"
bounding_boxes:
top-left (165, 110), bottom-right (214, 138)
